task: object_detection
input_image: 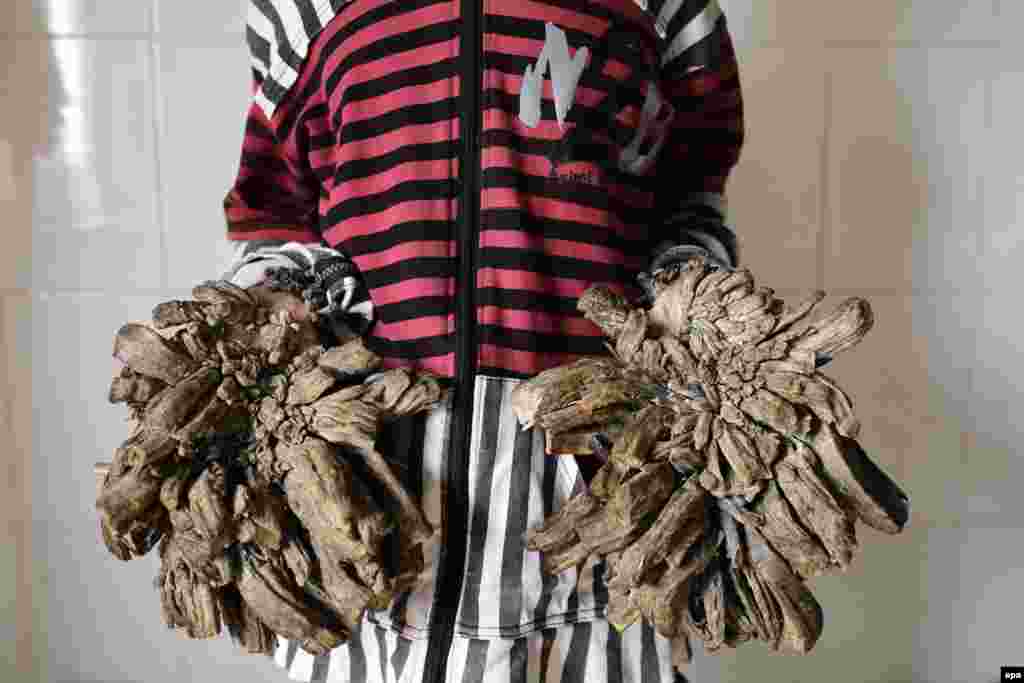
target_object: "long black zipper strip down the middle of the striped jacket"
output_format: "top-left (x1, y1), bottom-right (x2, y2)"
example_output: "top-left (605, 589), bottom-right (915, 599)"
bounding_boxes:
top-left (423, 0), bottom-right (483, 683)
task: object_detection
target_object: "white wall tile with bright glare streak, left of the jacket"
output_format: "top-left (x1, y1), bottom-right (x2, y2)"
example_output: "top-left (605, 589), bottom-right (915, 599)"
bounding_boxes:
top-left (28, 38), bottom-right (162, 290)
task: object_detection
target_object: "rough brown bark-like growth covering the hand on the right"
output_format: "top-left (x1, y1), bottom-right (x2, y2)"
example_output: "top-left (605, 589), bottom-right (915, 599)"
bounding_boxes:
top-left (512, 257), bottom-right (909, 671)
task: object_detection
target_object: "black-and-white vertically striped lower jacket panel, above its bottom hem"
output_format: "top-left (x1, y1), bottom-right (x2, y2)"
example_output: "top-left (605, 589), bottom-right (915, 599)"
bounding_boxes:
top-left (366, 376), bottom-right (608, 640)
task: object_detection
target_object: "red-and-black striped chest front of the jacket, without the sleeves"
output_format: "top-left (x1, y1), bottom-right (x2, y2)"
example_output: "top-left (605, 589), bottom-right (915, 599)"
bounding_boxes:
top-left (251, 0), bottom-right (680, 378)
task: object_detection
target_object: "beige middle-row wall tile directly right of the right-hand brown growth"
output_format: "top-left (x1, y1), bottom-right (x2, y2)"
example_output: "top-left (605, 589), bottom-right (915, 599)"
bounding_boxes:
top-left (802, 295), bottom-right (973, 526)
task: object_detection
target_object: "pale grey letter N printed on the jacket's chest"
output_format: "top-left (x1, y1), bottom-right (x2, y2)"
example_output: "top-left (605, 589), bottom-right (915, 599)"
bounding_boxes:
top-left (519, 22), bottom-right (590, 128)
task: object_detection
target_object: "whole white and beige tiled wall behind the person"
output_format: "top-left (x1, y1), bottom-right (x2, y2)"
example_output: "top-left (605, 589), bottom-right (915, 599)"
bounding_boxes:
top-left (0, 0), bottom-right (1024, 683)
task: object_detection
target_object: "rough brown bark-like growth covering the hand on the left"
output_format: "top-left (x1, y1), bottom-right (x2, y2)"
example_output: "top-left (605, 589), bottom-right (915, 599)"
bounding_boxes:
top-left (96, 281), bottom-right (442, 654)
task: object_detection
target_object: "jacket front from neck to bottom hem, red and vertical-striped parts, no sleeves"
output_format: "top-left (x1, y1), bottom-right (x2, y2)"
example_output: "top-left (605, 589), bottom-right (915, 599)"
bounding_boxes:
top-left (250, 0), bottom-right (712, 655)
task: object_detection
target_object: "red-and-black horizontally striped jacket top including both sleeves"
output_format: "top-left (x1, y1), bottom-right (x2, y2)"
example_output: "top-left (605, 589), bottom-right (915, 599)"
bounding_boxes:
top-left (224, 0), bottom-right (743, 378)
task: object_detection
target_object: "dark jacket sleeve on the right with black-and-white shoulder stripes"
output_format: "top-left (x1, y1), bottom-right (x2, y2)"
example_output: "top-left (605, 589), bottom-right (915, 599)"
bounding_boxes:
top-left (648, 0), bottom-right (744, 270)
